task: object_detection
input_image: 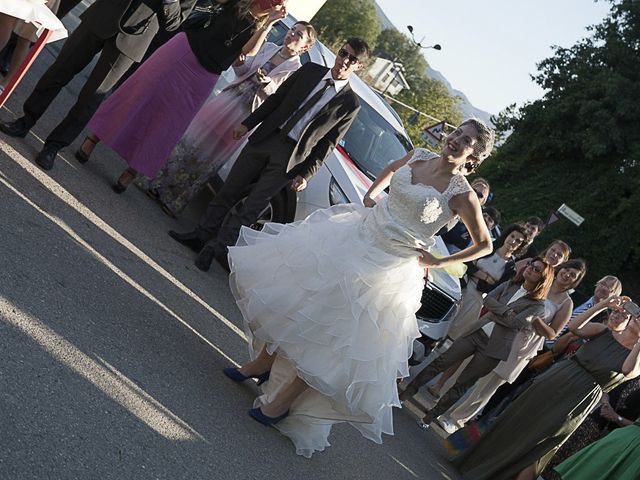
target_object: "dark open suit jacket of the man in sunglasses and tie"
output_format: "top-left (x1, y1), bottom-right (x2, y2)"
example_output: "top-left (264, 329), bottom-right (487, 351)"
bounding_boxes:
top-left (242, 62), bottom-right (360, 180)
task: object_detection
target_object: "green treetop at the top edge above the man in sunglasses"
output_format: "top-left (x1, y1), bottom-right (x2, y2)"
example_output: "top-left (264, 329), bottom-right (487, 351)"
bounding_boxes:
top-left (311, 0), bottom-right (380, 51)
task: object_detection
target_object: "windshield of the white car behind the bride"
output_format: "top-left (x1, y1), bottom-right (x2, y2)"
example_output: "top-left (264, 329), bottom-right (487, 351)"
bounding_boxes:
top-left (340, 101), bottom-right (413, 180)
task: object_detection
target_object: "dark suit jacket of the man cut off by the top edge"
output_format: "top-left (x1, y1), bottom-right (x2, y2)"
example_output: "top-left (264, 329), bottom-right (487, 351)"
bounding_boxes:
top-left (80, 0), bottom-right (195, 62)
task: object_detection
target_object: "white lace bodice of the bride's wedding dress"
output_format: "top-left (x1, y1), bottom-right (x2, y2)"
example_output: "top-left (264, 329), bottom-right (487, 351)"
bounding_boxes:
top-left (363, 148), bottom-right (471, 256)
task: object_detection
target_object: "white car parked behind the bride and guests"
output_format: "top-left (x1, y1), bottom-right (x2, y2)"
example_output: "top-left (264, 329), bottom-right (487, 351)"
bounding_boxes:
top-left (214, 17), bottom-right (461, 361)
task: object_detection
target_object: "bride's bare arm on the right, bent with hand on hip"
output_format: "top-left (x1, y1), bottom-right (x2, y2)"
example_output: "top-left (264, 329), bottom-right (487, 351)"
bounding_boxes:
top-left (420, 192), bottom-right (493, 267)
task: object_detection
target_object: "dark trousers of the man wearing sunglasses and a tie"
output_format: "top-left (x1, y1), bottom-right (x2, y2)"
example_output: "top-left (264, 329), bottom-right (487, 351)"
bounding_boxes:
top-left (198, 135), bottom-right (295, 255)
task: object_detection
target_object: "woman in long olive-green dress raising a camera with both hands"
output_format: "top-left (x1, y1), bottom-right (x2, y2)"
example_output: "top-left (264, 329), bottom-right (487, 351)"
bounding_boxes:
top-left (454, 297), bottom-right (640, 480)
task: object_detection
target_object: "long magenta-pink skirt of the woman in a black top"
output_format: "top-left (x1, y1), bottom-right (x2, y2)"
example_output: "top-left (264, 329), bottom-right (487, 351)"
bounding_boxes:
top-left (87, 33), bottom-right (218, 177)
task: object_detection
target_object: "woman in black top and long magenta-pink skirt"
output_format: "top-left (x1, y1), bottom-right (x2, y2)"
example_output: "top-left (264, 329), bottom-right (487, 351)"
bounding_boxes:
top-left (76, 0), bottom-right (286, 193)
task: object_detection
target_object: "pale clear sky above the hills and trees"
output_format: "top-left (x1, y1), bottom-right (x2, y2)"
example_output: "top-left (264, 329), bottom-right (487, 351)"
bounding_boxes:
top-left (376, 0), bottom-right (610, 114)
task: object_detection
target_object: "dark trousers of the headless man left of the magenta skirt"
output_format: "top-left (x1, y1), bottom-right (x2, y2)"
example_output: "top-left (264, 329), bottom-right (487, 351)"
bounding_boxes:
top-left (23, 23), bottom-right (133, 149)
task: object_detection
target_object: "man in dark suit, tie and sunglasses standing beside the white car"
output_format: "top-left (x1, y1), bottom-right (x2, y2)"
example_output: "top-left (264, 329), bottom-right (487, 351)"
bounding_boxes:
top-left (169, 38), bottom-right (369, 271)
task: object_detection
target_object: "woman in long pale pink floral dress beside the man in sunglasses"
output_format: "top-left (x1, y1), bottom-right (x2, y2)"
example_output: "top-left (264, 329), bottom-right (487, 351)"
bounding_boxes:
top-left (143, 22), bottom-right (317, 217)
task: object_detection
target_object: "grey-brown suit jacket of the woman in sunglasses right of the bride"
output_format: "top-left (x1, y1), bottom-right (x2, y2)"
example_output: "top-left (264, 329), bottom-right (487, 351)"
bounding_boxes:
top-left (483, 282), bottom-right (545, 360)
